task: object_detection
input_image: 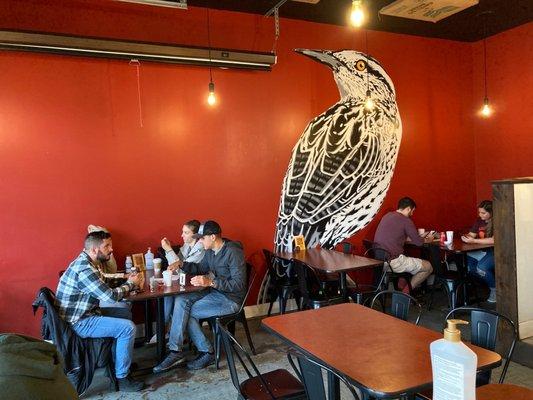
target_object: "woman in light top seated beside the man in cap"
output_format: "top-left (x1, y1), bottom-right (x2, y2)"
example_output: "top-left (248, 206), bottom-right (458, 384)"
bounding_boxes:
top-left (161, 219), bottom-right (205, 324)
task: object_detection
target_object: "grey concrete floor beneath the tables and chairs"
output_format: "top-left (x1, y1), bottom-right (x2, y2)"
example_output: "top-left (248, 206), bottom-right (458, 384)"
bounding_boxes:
top-left (82, 295), bottom-right (533, 400)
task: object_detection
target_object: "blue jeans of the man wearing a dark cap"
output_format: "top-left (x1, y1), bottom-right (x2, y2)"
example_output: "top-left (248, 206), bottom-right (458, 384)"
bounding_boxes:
top-left (168, 290), bottom-right (239, 353)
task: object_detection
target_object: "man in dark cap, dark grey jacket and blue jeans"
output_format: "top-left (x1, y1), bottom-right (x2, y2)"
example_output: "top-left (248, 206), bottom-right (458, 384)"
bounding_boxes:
top-left (154, 221), bottom-right (247, 373)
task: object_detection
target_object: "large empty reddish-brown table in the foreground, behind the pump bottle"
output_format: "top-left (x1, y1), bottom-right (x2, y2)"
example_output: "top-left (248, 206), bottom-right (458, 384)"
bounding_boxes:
top-left (262, 303), bottom-right (501, 399)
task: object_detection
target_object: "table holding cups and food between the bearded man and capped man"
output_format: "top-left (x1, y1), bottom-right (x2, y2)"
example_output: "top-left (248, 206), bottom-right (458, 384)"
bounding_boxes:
top-left (124, 270), bottom-right (205, 361)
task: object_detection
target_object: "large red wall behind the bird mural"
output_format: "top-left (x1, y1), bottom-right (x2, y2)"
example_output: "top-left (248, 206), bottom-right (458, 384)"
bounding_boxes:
top-left (0, 0), bottom-right (486, 335)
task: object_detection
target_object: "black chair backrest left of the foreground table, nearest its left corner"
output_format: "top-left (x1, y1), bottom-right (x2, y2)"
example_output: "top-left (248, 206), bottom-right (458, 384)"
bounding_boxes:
top-left (217, 322), bottom-right (275, 400)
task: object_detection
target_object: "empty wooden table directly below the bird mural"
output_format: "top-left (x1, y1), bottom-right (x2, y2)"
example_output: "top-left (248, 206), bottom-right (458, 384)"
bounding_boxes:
top-left (274, 249), bottom-right (383, 299)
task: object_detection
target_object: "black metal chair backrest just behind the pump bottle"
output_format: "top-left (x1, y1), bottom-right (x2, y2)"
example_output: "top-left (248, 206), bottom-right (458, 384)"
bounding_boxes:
top-left (444, 307), bottom-right (518, 383)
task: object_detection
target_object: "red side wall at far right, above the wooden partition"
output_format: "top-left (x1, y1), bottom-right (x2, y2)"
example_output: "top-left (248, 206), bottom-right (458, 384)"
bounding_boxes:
top-left (472, 23), bottom-right (533, 201)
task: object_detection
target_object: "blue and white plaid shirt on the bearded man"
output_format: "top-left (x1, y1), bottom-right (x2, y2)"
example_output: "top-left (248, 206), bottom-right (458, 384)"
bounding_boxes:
top-left (56, 251), bottom-right (133, 324)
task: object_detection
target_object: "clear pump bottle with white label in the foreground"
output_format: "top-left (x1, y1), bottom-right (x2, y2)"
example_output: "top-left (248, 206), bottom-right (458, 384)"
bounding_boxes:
top-left (429, 319), bottom-right (477, 400)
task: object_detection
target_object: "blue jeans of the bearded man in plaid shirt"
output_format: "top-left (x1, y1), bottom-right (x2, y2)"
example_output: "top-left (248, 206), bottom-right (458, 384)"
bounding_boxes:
top-left (72, 315), bottom-right (135, 378)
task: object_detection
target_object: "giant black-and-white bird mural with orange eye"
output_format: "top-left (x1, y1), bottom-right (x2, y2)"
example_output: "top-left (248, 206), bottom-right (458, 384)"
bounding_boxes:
top-left (275, 49), bottom-right (402, 250)
